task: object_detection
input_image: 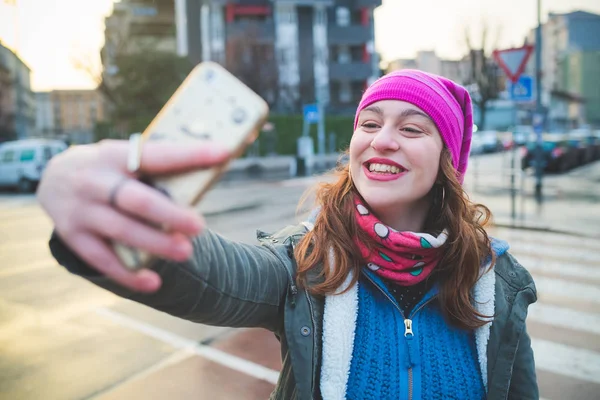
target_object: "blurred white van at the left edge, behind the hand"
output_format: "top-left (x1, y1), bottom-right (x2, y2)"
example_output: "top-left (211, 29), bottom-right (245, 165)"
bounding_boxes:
top-left (0, 139), bottom-right (67, 193)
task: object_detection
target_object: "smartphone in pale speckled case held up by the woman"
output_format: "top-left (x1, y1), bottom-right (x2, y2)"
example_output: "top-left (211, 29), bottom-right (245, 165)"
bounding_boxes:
top-left (113, 62), bottom-right (269, 270)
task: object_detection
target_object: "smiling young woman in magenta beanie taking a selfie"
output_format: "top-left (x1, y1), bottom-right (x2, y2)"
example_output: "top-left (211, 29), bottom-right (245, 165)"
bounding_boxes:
top-left (38, 70), bottom-right (538, 400)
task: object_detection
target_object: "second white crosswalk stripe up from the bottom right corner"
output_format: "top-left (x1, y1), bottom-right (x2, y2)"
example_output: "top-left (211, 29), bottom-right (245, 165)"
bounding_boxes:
top-left (527, 303), bottom-right (600, 335)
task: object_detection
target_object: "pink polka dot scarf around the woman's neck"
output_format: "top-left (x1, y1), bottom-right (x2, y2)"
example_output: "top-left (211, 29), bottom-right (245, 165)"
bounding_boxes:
top-left (355, 198), bottom-right (448, 286)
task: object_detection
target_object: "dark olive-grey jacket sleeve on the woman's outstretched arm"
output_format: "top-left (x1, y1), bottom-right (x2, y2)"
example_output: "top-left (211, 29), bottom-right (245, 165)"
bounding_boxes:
top-left (50, 231), bottom-right (292, 331)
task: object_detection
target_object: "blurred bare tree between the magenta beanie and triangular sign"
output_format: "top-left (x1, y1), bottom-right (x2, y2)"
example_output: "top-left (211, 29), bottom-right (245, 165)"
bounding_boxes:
top-left (465, 22), bottom-right (503, 129)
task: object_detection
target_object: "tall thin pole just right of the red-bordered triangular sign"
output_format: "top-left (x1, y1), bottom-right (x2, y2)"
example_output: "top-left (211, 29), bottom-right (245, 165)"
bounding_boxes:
top-left (534, 0), bottom-right (544, 204)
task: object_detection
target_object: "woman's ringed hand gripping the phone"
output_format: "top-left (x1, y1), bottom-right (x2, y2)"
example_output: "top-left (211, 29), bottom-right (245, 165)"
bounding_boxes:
top-left (37, 140), bottom-right (228, 292)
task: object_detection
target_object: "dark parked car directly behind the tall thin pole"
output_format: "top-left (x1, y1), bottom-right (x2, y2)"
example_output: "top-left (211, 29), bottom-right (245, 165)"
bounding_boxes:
top-left (521, 133), bottom-right (579, 172)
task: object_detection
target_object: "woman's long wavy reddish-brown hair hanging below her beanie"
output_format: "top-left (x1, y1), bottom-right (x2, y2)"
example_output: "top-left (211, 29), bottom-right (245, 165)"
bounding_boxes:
top-left (294, 148), bottom-right (495, 330)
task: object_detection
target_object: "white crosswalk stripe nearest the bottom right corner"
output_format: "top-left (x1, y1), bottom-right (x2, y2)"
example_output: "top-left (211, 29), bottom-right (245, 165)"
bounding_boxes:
top-left (531, 338), bottom-right (600, 384)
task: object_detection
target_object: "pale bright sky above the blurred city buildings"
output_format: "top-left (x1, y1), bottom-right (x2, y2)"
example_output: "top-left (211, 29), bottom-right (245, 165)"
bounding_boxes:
top-left (0, 0), bottom-right (600, 90)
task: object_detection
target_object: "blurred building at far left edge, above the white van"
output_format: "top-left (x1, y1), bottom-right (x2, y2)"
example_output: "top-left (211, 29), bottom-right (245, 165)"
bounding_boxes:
top-left (0, 43), bottom-right (35, 141)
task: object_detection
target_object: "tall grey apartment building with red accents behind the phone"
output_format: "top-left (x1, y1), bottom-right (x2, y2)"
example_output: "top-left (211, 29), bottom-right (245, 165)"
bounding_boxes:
top-left (175, 0), bottom-right (381, 113)
